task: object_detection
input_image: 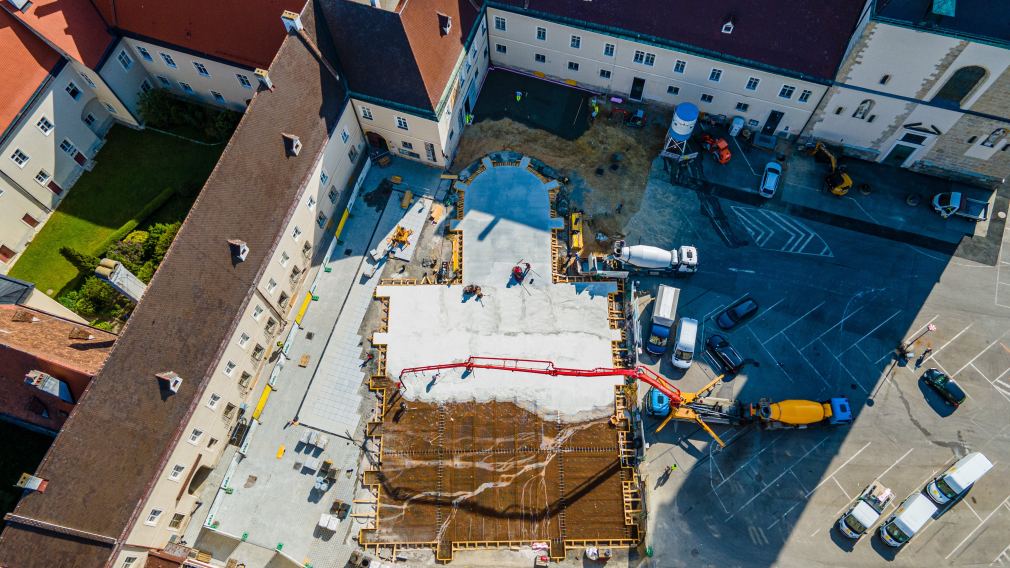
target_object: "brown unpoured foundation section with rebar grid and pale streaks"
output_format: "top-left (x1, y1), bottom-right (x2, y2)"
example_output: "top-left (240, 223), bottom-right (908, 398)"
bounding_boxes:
top-left (362, 381), bottom-right (637, 561)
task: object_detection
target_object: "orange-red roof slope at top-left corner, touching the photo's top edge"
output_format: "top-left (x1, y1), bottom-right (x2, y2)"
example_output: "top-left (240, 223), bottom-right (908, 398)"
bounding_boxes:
top-left (4, 0), bottom-right (112, 69)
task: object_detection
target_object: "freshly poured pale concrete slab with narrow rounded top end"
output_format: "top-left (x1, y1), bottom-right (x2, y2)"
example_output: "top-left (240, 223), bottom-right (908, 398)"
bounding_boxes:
top-left (375, 159), bottom-right (622, 420)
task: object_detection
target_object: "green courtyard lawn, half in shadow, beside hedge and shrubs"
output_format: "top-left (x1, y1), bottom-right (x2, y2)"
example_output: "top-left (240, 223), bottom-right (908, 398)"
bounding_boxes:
top-left (10, 126), bottom-right (224, 297)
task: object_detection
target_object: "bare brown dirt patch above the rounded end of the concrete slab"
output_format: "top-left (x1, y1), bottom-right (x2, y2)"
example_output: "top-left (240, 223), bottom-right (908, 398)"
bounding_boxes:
top-left (451, 107), bottom-right (671, 252)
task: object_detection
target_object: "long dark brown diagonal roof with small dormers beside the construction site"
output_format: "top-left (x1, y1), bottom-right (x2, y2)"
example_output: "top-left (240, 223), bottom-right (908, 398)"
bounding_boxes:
top-left (0, 2), bottom-right (344, 568)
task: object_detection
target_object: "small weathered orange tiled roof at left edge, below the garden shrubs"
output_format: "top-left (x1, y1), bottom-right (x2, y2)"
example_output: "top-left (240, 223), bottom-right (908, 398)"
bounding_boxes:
top-left (0, 305), bottom-right (116, 375)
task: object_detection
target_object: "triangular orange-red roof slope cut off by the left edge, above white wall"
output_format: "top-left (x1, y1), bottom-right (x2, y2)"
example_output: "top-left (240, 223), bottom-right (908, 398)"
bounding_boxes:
top-left (0, 8), bottom-right (62, 127)
